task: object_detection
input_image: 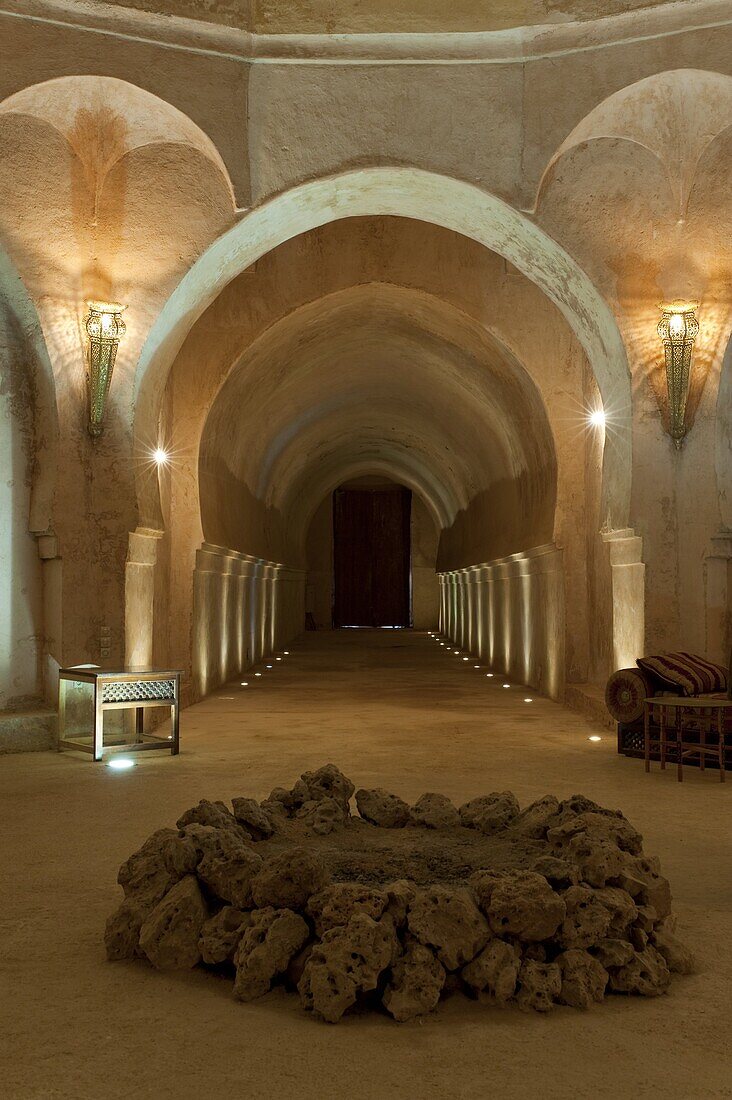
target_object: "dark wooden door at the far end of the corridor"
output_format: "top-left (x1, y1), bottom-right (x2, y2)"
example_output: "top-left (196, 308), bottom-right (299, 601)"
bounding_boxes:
top-left (334, 488), bottom-right (412, 627)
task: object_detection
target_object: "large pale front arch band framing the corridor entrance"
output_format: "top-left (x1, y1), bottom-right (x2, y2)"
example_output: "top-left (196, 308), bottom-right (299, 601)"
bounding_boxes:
top-left (134, 168), bottom-right (632, 528)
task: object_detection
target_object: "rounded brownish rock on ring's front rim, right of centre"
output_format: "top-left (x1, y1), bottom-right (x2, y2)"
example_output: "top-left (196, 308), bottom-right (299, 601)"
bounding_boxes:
top-left (485, 871), bottom-right (566, 943)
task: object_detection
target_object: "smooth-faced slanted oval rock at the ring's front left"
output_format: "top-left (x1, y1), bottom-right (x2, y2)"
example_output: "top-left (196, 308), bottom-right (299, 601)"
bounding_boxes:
top-left (140, 875), bottom-right (208, 970)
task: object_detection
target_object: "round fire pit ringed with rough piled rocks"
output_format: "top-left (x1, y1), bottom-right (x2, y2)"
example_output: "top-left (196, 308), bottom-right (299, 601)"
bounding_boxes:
top-left (105, 765), bottom-right (693, 1023)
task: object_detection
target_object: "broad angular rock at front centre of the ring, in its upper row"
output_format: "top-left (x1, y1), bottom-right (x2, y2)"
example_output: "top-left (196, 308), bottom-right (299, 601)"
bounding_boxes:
top-left (407, 886), bottom-right (491, 970)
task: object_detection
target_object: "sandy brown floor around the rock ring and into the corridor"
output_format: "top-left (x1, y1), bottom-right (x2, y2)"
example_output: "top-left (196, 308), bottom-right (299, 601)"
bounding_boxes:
top-left (0, 631), bottom-right (732, 1100)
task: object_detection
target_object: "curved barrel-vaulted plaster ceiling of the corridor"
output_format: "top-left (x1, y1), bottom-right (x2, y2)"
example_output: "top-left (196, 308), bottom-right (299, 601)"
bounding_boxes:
top-left (199, 284), bottom-right (556, 567)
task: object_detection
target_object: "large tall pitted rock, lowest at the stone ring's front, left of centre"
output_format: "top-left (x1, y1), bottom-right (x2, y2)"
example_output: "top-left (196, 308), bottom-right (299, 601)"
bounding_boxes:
top-left (297, 913), bottom-right (394, 1023)
